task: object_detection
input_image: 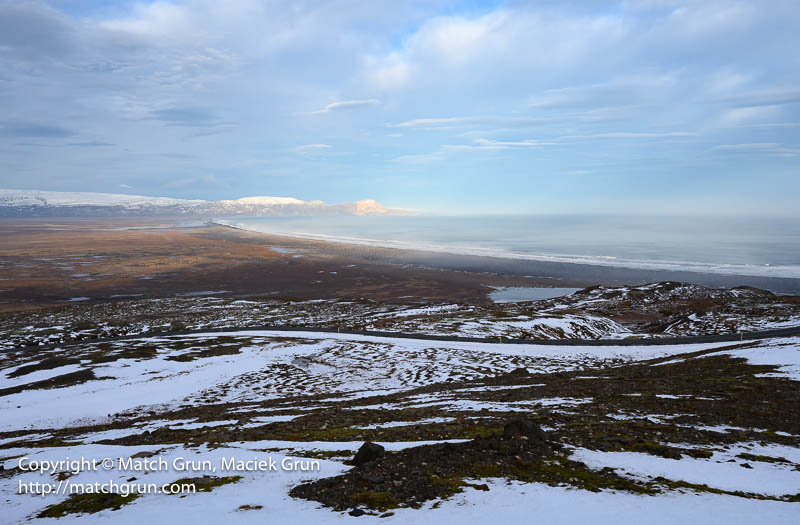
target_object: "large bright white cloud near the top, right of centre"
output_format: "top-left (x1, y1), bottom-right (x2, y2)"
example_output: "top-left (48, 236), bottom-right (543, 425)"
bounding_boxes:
top-left (363, 5), bottom-right (628, 94)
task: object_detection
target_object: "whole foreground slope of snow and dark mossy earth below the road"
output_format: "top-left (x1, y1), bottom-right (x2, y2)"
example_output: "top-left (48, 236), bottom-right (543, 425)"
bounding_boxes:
top-left (0, 328), bottom-right (800, 524)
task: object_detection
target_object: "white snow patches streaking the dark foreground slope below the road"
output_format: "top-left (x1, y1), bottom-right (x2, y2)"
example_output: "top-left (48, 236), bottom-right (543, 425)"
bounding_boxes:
top-left (0, 330), bottom-right (800, 525)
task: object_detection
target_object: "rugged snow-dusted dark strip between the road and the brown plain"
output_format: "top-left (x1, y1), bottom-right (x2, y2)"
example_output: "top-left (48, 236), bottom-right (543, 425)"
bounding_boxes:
top-left (0, 280), bottom-right (800, 349)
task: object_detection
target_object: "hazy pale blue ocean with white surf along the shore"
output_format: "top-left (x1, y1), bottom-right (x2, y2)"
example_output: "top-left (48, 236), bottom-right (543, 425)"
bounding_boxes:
top-left (215, 215), bottom-right (800, 278)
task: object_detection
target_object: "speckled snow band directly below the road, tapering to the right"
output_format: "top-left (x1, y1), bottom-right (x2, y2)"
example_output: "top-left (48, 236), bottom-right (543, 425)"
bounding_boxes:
top-left (0, 330), bottom-right (736, 430)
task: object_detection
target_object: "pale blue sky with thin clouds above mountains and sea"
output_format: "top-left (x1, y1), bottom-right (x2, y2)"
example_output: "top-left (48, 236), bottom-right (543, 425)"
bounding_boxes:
top-left (0, 0), bottom-right (800, 216)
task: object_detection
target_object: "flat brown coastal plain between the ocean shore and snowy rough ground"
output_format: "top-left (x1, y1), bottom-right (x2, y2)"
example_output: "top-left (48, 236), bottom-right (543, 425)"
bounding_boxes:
top-left (0, 217), bottom-right (800, 311)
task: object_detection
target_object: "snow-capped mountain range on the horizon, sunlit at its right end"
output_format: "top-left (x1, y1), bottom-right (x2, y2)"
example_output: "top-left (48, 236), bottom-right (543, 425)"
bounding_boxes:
top-left (0, 190), bottom-right (414, 217)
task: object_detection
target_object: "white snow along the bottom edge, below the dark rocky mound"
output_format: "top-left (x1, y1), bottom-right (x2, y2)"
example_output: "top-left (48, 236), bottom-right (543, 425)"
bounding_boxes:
top-left (0, 445), bottom-right (798, 525)
